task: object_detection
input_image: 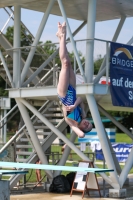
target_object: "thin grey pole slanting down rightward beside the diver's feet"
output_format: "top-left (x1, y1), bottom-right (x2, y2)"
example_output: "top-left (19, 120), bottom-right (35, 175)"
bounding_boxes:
top-left (58, 0), bottom-right (86, 82)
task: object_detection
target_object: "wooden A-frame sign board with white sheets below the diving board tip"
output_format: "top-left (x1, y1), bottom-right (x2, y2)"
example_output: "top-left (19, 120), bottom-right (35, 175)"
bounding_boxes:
top-left (70, 161), bottom-right (101, 198)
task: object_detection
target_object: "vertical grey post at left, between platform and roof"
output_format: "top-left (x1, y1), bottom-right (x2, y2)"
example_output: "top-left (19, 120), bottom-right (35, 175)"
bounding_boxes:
top-left (13, 5), bottom-right (21, 87)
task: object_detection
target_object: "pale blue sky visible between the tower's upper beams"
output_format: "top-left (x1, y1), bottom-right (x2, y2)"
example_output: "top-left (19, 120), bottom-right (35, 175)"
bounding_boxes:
top-left (0, 8), bottom-right (133, 56)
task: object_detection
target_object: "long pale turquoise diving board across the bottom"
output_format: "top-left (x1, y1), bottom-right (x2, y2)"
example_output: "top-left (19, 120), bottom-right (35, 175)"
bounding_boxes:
top-left (0, 162), bottom-right (114, 173)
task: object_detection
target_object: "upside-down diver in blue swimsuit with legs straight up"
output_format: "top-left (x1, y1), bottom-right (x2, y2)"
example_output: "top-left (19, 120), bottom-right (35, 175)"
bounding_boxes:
top-left (56, 22), bottom-right (92, 138)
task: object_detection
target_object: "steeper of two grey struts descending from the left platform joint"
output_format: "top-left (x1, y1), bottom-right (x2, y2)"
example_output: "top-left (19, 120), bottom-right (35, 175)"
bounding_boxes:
top-left (16, 99), bottom-right (53, 178)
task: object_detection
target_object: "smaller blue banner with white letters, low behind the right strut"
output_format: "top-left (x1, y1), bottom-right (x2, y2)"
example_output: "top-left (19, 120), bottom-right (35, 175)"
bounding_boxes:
top-left (95, 144), bottom-right (133, 162)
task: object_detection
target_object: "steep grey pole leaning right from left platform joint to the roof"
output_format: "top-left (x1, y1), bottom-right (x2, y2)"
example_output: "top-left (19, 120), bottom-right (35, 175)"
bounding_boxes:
top-left (21, 0), bottom-right (55, 83)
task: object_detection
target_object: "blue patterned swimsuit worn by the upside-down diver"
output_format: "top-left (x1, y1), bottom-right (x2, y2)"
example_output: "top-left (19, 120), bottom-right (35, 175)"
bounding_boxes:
top-left (58, 85), bottom-right (81, 123)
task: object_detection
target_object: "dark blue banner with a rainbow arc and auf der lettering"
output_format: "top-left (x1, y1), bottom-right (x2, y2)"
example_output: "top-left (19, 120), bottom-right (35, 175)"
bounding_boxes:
top-left (110, 42), bottom-right (133, 107)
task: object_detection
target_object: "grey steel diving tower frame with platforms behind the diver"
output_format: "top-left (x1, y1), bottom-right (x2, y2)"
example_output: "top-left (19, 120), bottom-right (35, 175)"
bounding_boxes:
top-left (0, 0), bottom-right (133, 192)
